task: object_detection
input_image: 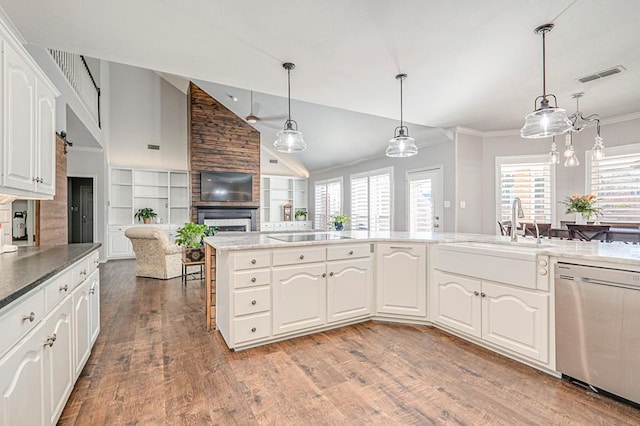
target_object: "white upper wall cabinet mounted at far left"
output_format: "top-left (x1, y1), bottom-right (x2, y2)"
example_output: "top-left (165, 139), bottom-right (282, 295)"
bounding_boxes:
top-left (0, 29), bottom-right (58, 199)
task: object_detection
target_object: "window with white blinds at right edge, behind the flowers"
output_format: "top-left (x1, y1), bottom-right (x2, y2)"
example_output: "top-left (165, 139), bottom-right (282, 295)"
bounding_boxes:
top-left (586, 144), bottom-right (640, 222)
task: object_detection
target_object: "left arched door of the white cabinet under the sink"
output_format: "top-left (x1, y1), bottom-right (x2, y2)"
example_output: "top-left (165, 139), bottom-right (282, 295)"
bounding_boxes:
top-left (429, 270), bottom-right (482, 337)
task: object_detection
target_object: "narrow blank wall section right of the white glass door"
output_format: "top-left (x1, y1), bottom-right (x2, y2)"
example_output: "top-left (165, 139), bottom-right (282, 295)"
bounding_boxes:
top-left (456, 131), bottom-right (483, 233)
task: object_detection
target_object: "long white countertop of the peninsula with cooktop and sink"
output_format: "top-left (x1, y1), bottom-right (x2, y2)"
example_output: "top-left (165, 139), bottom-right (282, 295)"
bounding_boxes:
top-left (205, 231), bottom-right (640, 267)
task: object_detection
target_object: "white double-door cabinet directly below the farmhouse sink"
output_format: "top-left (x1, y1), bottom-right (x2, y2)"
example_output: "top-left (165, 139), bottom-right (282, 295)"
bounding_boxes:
top-left (430, 270), bottom-right (549, 363)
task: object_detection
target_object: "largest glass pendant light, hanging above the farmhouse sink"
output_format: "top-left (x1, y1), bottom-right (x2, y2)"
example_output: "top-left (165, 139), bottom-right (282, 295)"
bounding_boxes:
top-left (520, 24), bottom-right (572, 138)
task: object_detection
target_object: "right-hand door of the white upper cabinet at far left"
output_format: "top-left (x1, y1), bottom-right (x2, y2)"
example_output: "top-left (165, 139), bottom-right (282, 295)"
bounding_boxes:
top-left (36, 81), bottom-right (56, 195)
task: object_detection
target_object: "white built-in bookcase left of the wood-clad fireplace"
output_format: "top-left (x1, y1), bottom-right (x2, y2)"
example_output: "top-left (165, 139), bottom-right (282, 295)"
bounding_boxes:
top-left (107, 167), bottom-right (190, 258)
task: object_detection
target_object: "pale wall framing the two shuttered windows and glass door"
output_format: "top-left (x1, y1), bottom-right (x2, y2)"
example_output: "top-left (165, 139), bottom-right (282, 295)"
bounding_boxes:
top-left (309, 141), bottom-right (456, 232)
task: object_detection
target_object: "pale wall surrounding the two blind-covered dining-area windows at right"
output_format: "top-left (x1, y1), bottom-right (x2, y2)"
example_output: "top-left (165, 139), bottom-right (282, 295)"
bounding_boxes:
top-left (481, 115), bottom-right (640, 234)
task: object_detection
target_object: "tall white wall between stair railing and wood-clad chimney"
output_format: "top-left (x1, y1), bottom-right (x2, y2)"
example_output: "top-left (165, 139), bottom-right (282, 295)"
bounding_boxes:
top-left (107, 63), bottom-right (188, 170)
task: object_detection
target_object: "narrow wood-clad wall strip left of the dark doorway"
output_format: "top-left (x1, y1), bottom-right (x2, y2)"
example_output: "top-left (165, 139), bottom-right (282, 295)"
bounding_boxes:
top-left (36, 135), bottom-right (69, 246)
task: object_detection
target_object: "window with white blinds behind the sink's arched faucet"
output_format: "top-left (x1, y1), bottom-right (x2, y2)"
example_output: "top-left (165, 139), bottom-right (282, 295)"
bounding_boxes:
top-left (496, 155), bottom-right (555, 223)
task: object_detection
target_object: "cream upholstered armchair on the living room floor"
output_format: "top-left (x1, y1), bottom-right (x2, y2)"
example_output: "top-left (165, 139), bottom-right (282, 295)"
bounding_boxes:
top-left (124, 226), bottom-right (182, 280)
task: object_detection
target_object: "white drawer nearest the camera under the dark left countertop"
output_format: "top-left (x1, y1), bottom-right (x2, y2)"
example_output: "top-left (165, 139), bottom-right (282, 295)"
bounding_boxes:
top-left (0, 289), bottom-right (44, 357)
